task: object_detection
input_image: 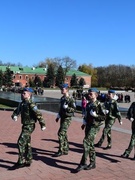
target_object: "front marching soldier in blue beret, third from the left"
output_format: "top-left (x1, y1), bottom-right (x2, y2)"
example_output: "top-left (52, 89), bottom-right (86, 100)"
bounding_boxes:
top-left (76, 88), bottom-right (105, 172)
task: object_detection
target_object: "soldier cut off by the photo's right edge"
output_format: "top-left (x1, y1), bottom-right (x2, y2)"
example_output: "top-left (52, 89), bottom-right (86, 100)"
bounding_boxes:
top-left (121, 102), bottom-right (135, 160)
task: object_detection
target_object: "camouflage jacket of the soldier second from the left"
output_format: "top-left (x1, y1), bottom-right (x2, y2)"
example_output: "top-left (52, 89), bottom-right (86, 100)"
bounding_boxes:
top-left (59, 96), bottom-right (76, 118)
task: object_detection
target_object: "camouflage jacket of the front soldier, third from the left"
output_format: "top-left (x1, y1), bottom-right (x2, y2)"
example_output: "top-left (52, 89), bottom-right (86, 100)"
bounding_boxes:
top-left (84, 100), bottom-right (106, 126)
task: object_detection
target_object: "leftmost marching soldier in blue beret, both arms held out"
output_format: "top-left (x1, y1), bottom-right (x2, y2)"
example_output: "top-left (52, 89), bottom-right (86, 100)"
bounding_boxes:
top-left (11, 88), bottom-right (46, 168)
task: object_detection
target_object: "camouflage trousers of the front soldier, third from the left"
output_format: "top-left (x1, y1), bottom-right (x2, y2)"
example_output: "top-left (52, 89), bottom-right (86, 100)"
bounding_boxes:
top-left (80, 126), bottom-right (100, 164)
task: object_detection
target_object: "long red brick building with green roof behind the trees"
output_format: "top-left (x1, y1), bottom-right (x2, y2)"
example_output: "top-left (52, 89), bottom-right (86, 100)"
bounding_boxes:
top-left (0, 66), bottom-right (91, 87)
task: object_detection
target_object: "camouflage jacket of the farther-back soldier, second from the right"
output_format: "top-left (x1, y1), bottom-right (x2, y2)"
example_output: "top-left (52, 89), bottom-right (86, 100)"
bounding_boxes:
top-left (104, 99), bottom-right (121, 120)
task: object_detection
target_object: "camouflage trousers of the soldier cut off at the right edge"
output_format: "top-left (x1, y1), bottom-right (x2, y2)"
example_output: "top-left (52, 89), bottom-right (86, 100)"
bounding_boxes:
top-left (124, 120), bottom-right (135, 156)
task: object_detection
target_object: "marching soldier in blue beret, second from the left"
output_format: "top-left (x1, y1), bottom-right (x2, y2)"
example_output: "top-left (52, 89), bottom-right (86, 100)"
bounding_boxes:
top-left (54, 84), bottom-right (75, 157)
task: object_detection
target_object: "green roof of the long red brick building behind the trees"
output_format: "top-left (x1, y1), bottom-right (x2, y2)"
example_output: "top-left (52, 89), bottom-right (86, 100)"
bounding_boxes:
top-left (0, 66), bottom-right (91, 76)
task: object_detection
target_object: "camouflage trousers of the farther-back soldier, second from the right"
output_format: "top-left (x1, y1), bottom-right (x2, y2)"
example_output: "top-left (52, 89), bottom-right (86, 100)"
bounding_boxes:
top-left (98, 119), bottom-right (115, 146)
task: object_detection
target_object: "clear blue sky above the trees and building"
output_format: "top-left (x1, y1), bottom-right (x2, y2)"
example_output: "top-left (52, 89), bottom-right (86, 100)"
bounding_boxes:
top-left (0, 0), bottom-right (135, 67)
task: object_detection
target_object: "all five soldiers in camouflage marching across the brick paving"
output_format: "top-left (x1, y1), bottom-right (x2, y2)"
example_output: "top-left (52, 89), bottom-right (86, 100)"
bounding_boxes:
top-left (11, 84), bottom-right (135, 172)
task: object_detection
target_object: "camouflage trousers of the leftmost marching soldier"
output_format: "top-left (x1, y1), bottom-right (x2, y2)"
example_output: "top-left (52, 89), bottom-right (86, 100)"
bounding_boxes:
top-left (17, 124), bottom-right (35, 164)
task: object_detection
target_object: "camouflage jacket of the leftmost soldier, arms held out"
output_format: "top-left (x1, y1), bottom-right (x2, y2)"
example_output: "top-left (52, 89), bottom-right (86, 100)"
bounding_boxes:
top-left (12, 99), bottom-right (45, 127)
